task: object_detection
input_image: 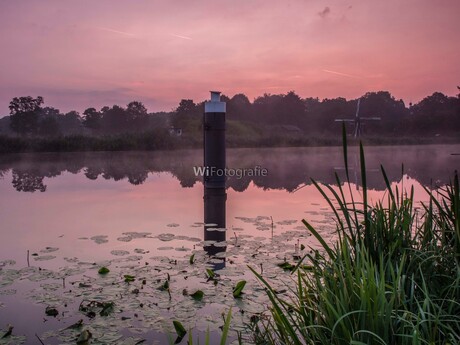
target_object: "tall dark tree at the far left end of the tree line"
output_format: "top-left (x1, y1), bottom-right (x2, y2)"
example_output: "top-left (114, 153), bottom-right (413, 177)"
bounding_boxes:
top-left (9, 96), bottom-right (43, 136)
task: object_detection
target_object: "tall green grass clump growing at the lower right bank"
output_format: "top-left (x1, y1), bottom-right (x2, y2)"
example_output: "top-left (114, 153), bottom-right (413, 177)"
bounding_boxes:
top-left (251, 130), bottom-right (460, 345)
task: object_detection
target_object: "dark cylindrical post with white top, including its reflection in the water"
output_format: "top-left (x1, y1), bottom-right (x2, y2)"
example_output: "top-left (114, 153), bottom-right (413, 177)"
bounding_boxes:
top-left (203, 91), bottom-right (227, 266)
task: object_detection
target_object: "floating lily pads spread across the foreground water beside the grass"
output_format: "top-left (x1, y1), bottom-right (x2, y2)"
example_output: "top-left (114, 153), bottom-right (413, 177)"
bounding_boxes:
top-left (0, 218), bottom-right (307, 344)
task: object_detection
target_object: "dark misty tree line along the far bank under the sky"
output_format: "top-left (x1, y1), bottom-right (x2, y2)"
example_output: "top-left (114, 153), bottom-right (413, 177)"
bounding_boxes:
top-left (0, 89), bottom-right (460, 138)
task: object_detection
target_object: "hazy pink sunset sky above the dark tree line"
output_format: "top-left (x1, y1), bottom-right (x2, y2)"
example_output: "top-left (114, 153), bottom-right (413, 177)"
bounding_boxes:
top-left (0, 0), bottom-right (460, 116)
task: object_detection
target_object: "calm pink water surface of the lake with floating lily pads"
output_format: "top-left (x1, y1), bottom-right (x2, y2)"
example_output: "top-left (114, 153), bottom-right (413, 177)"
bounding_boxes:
top-left (0, 145), bottom-right (460, 344)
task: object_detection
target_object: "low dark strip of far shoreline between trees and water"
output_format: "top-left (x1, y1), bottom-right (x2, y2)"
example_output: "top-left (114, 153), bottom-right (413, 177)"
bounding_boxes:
top-left (0, 133), bottom-right (460, 154)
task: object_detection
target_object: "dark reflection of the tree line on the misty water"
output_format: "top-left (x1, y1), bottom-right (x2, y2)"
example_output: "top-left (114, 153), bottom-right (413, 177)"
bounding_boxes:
top-left (0, 145), bottom-right (460, 192)
